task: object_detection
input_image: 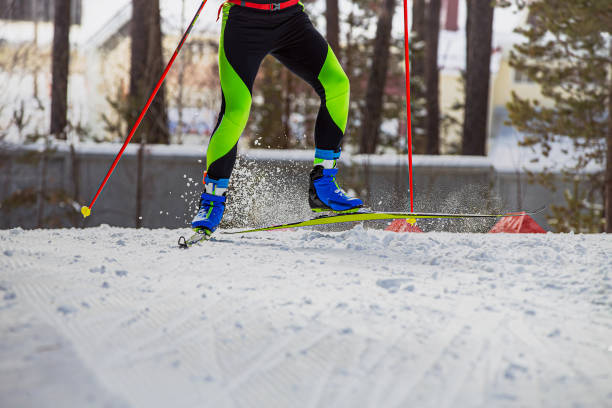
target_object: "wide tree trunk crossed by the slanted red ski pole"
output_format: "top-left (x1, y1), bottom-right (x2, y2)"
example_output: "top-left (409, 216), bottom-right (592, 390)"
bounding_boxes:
top-left (130, 0), bottom-right (170, 144)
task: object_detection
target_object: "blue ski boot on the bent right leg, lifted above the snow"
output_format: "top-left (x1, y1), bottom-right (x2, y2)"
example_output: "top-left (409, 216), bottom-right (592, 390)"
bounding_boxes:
top-left (308, 149), bottom-right (363, 213)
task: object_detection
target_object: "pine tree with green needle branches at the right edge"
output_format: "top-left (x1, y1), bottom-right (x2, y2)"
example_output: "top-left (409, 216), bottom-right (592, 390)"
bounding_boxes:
top-left (508, 0), bottom-right (612, 232)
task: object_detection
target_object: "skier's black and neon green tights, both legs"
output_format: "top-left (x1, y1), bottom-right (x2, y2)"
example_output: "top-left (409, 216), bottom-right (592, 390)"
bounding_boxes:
top-left (206, 3), bottom-right (350, 180)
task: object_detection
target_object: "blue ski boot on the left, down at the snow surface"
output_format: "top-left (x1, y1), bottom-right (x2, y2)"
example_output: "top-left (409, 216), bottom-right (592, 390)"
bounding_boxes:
top-left (191, 176), bottom-right (229, 235)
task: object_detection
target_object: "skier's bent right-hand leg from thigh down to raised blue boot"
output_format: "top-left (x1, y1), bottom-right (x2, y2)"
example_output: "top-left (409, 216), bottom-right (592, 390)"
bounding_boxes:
top-left (272, 12), bottom-right (363, 212)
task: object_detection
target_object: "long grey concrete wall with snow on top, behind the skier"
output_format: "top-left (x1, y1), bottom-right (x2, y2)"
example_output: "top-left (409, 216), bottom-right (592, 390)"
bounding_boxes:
top-left (0, 145), bottom-right (563, 231)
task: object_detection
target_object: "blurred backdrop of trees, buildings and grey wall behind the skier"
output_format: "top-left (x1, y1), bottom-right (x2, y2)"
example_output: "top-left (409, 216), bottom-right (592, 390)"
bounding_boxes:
top-left (0, 0), bottom-right (612, 232)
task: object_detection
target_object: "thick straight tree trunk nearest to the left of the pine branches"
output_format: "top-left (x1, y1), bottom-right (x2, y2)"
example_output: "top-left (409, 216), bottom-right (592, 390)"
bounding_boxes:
top-left (463, 0), bottom-right (494, 156)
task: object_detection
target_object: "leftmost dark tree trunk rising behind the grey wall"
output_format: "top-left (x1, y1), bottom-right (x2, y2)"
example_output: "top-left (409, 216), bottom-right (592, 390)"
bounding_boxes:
top-left (50, 0), bottom-right (70, 140)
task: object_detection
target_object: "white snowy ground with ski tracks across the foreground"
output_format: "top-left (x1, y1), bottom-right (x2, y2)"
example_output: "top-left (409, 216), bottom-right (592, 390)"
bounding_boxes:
top-left (0, 226), bottom-right (612, 408)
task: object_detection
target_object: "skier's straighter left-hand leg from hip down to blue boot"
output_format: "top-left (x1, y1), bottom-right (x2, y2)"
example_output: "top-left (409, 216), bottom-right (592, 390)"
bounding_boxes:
top-left (191, 3), bottom-right (268, 233)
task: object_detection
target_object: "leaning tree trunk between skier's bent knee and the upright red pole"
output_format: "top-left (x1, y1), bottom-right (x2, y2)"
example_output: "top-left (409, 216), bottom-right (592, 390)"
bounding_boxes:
top-left (359, 0), bottom-right (395, 154)
